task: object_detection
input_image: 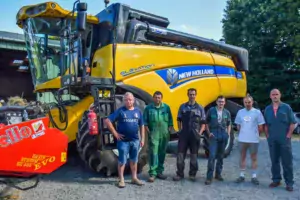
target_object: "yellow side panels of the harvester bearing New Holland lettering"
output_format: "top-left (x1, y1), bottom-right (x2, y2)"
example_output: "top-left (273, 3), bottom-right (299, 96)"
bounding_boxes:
top-left (92, 44), bottom-right (247, 130)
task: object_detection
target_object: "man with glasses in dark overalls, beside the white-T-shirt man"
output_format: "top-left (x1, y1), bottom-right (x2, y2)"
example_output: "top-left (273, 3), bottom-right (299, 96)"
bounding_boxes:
top-left (205, 96), bottom-right (231, 185)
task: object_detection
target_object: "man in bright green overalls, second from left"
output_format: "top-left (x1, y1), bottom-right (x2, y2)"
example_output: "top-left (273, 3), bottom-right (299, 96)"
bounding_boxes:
top-left (143, 91), bottom-right (173, 182)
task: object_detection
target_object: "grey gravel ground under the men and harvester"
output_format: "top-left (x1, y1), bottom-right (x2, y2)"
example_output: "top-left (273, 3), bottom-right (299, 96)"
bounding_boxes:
top-left (0, 139), bottom-right (300, 200)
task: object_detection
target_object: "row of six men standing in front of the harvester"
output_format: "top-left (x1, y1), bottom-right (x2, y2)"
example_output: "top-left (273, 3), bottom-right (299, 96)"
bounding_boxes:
top-left (105, 88), bottom-right (296, 191)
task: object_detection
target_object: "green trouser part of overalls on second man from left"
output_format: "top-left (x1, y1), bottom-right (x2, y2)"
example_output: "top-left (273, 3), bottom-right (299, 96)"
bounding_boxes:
top-left (148, 125), bottom-right (170, 176)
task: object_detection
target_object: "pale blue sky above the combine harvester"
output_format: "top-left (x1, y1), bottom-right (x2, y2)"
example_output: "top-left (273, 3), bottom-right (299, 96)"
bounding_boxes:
top-left (0, 0), bottom-right (226, 40)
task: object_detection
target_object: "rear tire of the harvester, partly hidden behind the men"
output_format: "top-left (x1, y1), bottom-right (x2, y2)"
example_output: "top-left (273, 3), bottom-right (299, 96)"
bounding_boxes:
top-left (202, 100), bottom-right (243, 158)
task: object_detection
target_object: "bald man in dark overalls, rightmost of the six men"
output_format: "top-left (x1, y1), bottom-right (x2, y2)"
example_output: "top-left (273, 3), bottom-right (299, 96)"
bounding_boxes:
top-left (264, 89), bottom-right (296, 191)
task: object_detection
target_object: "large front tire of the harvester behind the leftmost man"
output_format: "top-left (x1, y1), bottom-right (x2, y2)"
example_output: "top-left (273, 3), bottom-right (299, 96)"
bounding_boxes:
top-left (76, 95), bottom-right (148, 176)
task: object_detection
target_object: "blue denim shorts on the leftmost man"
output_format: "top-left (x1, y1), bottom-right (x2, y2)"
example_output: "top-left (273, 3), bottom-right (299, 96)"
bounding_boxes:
top-left (117, 140), bottom-right (140, 165)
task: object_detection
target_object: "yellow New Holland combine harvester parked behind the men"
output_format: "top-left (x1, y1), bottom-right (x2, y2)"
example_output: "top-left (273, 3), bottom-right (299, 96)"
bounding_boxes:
top-left (17, 1), bottom-right (248, 176)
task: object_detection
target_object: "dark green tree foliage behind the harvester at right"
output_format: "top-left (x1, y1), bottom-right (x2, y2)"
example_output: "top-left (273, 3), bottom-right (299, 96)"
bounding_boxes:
top-left (222, 0), bottom-right (300, 110)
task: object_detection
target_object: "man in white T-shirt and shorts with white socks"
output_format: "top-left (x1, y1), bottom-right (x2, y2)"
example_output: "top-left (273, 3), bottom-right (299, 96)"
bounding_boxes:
top-left (235, 95), bottom-right (265, 185)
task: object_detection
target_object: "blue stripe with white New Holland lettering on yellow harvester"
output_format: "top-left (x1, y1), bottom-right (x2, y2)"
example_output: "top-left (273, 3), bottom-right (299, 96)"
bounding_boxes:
top-left (156, 65), bottom-right (243, 89)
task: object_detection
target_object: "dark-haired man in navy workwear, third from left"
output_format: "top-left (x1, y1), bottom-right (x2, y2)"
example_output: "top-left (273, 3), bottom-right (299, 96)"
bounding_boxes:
top-left (173, 88), bottom-right (205, 181)
